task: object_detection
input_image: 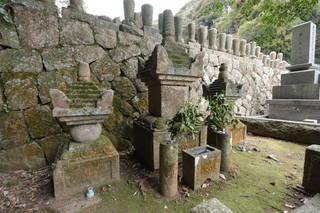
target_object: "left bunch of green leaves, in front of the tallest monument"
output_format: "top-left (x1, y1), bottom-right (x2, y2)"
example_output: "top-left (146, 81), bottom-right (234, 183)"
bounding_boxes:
top-left (168, 103), bottom-right (203, 139)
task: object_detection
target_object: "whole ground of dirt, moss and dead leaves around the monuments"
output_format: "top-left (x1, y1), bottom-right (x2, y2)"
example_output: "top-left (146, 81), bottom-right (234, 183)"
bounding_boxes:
top-left (0, 136), bottom-right (312, 213)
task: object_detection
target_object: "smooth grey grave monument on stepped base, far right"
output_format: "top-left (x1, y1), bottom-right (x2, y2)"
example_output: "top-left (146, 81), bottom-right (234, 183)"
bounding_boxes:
top-left (267, 22), bottom-right (320, 123)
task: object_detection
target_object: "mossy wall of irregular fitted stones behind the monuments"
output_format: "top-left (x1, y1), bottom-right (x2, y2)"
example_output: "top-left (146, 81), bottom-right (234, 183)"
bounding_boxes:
top-left (0, 0), bottom-right (282, 171)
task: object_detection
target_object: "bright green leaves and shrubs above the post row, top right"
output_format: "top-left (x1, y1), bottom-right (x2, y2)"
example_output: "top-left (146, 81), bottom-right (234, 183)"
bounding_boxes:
top-left (204, 0), bottom-right (320, 60)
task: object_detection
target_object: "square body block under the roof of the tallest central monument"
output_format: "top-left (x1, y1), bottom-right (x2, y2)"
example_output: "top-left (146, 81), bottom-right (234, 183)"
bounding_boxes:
top-left (149, 85), bottom-right (189, 117)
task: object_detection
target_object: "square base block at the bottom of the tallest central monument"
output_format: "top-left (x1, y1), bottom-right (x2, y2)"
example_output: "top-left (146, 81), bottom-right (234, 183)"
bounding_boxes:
top-left (133, 122), bottom-right (207, 170)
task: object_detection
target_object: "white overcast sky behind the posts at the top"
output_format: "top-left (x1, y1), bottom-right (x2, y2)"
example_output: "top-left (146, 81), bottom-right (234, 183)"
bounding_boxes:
top-left (85, 0), bottom-right (189, 20)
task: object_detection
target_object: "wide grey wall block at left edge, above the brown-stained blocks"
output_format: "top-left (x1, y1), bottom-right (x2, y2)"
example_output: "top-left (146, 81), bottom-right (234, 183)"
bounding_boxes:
top-left (0, 49), bottom-right (43, 72)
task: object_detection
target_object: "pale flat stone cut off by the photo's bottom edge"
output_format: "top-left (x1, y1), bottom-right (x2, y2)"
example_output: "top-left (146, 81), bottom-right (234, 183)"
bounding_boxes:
top-left (191, 198), bottom-right (232, 213)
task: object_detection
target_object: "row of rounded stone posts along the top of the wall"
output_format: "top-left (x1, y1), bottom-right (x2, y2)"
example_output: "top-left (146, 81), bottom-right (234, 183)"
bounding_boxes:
top-left (123, 0), bottom-right (284, 68)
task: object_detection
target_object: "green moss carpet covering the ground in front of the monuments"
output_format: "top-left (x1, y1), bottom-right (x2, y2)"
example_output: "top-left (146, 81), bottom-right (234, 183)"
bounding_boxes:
top-left (87, 137), bottom-right (305, 213)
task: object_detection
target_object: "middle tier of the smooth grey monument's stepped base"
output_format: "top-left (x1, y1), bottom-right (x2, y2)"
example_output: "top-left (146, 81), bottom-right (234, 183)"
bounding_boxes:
top-left (272, 84), bottom-right (320, 100)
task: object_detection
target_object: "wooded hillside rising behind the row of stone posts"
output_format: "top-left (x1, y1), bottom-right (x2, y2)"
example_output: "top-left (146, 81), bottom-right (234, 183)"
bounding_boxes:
top-left (177, 0), bottom-right (320, 62)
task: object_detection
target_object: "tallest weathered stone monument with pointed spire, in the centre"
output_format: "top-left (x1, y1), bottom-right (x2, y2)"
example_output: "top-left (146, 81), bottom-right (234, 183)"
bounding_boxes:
top-left (134, 10), bottom-right (207, 169)
